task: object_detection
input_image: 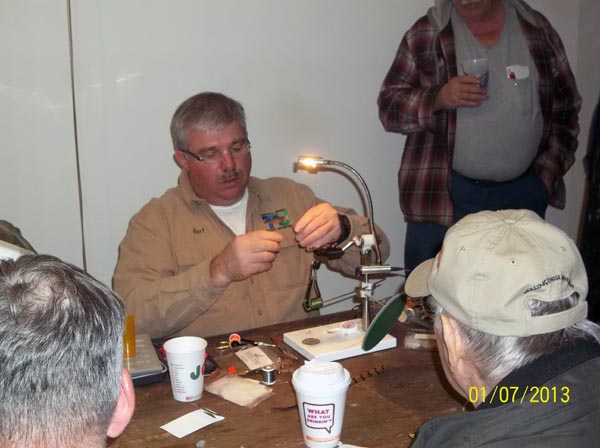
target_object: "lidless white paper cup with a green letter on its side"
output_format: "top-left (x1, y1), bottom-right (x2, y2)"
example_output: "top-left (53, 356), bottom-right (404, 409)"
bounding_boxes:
top-left (163, 336), bottom-right (207, 401)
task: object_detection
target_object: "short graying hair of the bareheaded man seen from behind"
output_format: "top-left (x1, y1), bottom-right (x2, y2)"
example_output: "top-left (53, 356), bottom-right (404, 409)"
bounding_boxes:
top-left (0, 255), bottom-right (125, 447)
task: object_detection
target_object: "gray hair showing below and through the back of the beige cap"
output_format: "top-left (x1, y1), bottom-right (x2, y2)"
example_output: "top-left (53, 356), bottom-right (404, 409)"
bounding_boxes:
top-left (428, 293), bottom-right (600, 384)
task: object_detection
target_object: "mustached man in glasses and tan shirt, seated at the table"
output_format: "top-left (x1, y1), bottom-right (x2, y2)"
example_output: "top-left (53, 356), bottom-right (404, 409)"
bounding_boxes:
top-left (113, 92), bottom-right (389, 338)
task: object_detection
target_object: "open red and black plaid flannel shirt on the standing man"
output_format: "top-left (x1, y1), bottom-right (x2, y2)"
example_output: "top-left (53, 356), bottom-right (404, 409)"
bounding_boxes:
top-left (377, 0), bottom-right (581, 226)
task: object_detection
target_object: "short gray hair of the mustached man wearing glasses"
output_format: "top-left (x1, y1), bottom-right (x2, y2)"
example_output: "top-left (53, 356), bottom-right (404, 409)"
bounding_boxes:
top-left (171, 92), bottom-right (248, 151)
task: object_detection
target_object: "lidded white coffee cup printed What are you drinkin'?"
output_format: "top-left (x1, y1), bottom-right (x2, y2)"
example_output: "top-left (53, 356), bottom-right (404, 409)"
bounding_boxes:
top-left (292, 360), bottom-right (350, 448)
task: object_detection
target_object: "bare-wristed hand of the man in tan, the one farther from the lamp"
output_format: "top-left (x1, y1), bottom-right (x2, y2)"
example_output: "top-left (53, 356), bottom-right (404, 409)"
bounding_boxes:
top-left (210, 230), bottom-right (283, 288)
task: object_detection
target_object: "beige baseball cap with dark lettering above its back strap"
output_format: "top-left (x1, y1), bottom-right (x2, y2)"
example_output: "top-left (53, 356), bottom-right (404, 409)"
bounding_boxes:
top-left (404, 210), bottom-right (588, 336)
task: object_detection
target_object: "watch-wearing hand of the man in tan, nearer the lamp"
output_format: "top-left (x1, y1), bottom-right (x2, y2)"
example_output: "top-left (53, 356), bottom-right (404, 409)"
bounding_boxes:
top-left (294, 202), bottom-right (342, 250)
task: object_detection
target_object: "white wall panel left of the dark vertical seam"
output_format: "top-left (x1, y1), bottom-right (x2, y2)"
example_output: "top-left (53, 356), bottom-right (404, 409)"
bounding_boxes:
top-left (0, 0), bottom-right (83, 265)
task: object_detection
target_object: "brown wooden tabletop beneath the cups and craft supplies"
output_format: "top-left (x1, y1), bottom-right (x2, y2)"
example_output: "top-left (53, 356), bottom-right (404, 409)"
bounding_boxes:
top-left (109, 311), bottom-right (462, 448)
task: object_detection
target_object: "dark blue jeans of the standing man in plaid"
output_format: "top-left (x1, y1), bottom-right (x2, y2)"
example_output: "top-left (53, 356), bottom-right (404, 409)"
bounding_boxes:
top-left (404, 169), bottom-right (550, 271)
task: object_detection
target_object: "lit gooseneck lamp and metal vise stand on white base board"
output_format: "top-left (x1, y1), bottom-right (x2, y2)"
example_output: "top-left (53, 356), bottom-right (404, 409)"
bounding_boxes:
top-left (284, 155), bottom-right (405, 361)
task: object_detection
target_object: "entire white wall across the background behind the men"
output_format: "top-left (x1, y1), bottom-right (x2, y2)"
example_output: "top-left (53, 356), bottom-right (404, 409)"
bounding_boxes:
top-left (0, 0), bottom-right (600, 316)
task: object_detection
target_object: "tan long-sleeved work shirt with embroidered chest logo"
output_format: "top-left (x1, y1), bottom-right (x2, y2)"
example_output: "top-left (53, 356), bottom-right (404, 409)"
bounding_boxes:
top-left (113, 171), bottom-right (389, 339)
